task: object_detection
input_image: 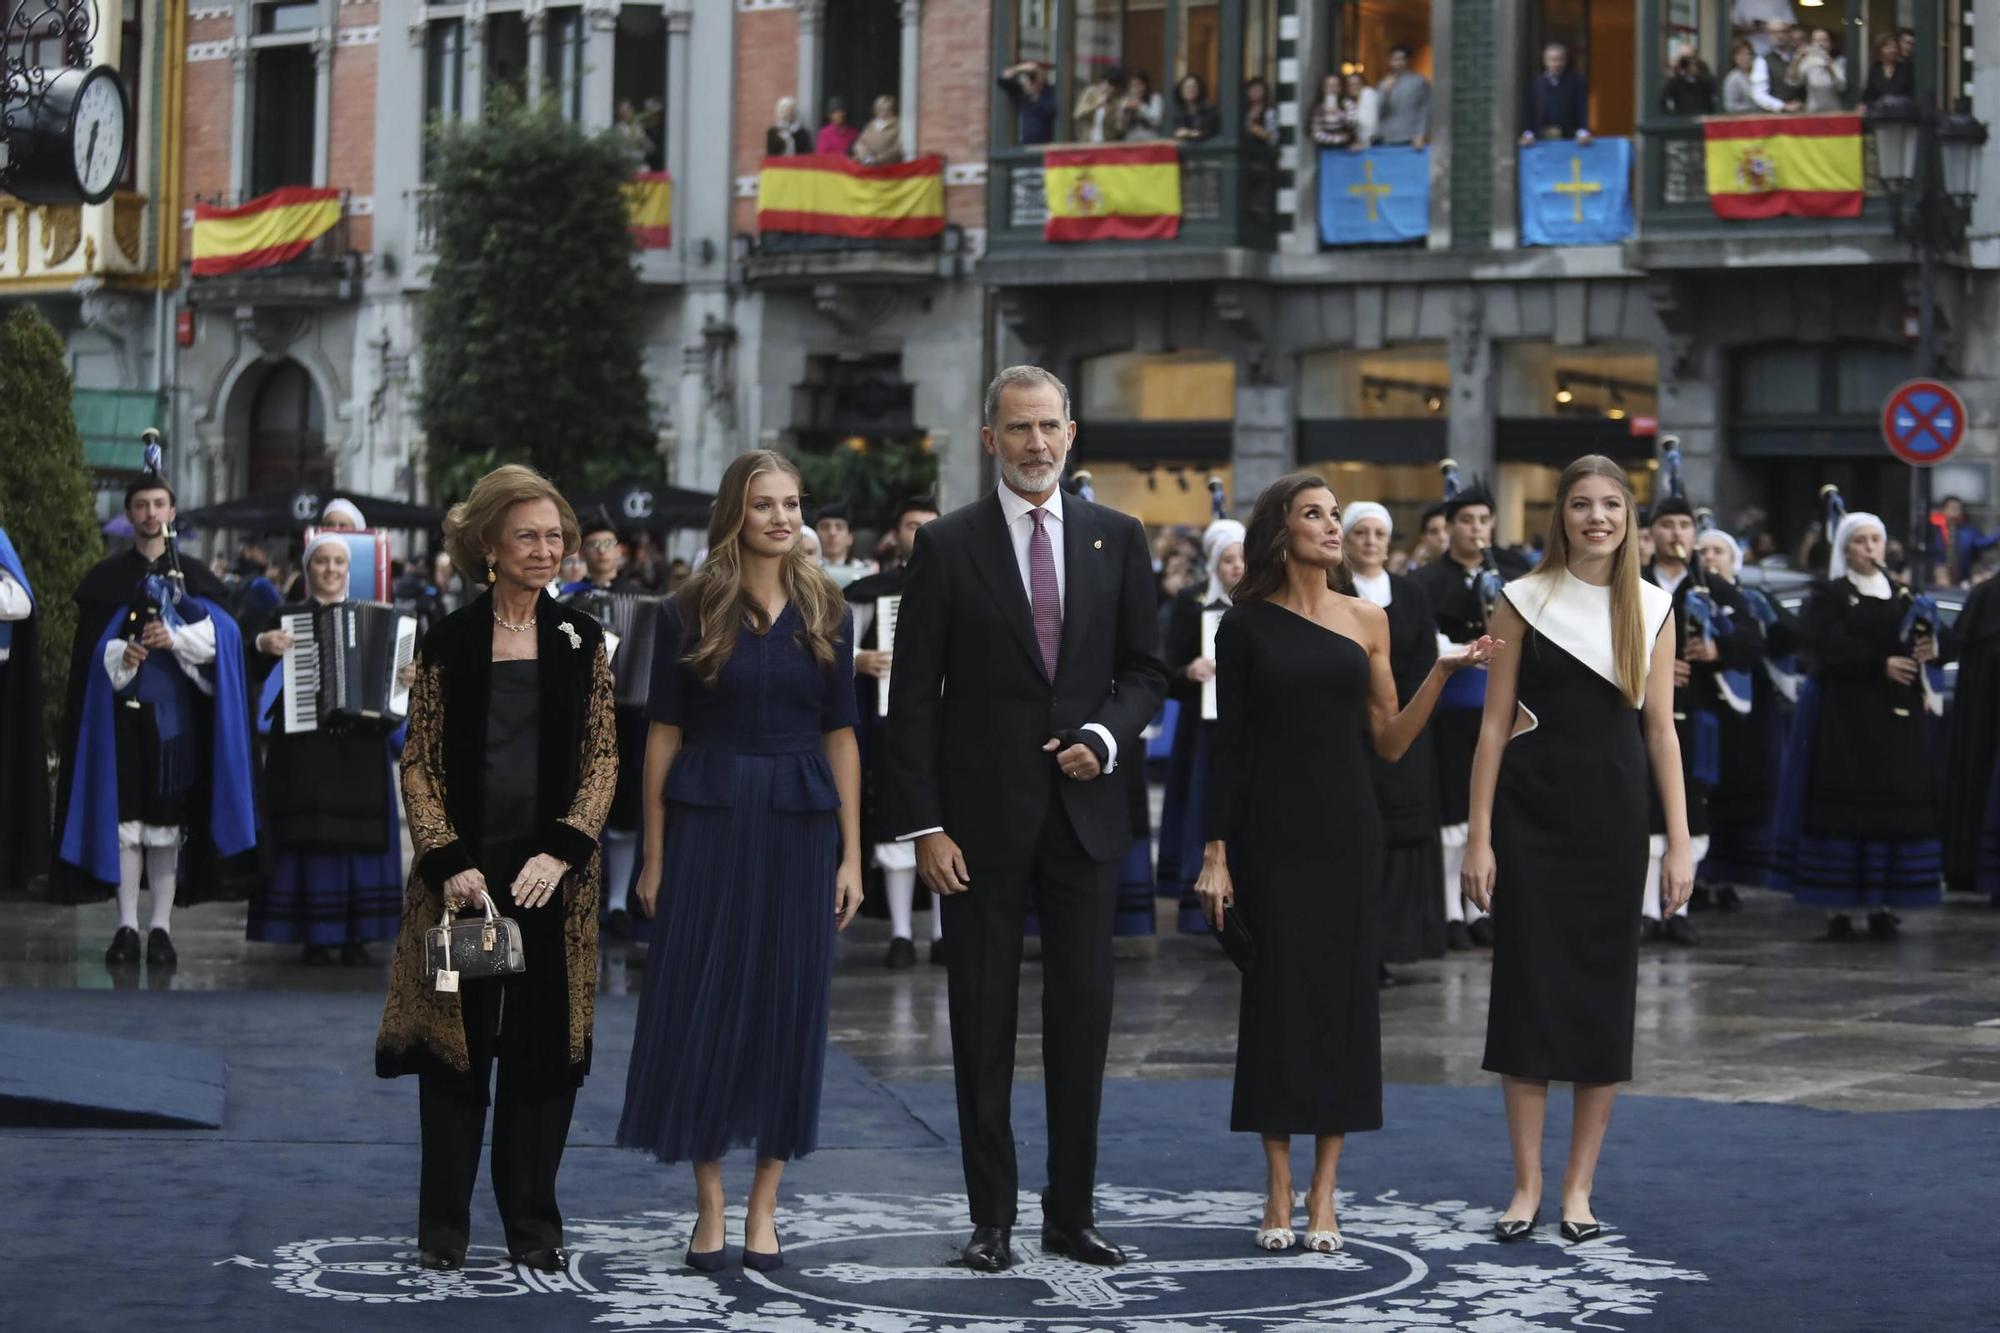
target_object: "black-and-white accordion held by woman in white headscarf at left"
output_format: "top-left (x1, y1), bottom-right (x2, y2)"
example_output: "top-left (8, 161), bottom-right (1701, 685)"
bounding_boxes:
top-left (278, 602), bottom-right (416, 733)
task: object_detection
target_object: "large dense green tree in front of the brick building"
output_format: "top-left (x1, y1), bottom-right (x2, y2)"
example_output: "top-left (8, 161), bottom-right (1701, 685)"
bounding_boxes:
top-left (420, 94), bottom-right (660, 496)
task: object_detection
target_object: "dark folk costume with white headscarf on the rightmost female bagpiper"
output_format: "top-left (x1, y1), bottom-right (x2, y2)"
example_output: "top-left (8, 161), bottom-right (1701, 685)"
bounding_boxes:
top-left (1776, 512), bottom-right (1946, 939)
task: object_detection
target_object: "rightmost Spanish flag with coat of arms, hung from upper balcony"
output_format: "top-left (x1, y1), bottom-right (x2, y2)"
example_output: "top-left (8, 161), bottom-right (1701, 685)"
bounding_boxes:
top-left (1702, 112), bottom-right (1862, 218)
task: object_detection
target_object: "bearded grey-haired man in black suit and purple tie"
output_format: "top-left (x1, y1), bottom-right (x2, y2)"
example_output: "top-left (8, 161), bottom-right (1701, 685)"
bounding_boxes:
top-left (886, 366), bottom-right (1166, 1273)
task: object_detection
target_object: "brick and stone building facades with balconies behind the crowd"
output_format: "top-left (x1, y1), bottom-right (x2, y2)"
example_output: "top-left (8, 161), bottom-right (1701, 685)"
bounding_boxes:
top-left (146, 0), bottom-right (2000, 556)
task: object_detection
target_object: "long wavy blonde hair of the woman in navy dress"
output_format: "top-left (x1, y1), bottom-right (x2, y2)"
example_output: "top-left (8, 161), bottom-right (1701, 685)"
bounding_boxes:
top-left (678, 448), bottom-right (846, 687)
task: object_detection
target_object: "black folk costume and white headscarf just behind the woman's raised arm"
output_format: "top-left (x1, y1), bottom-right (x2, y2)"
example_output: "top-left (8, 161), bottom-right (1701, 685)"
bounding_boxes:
top-left (1340, 500), bottom-right (1444, 963)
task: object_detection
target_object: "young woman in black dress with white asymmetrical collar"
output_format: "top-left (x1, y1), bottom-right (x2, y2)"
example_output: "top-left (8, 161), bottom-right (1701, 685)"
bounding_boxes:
top-left (1462, 454), bottom-right (1694, 1241)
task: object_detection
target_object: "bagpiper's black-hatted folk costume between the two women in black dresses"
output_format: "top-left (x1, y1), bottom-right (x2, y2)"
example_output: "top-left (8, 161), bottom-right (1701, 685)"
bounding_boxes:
top-left (1412, 478), bottom-right (1526, 949)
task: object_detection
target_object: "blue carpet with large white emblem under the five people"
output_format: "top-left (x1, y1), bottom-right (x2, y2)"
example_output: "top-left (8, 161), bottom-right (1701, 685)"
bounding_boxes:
top-left (0, 991), bottom-right (2000, 1333)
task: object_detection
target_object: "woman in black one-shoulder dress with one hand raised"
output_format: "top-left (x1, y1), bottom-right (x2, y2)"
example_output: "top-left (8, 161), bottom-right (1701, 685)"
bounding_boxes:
top-left (1196, 472), bottom-right (1502, 1253)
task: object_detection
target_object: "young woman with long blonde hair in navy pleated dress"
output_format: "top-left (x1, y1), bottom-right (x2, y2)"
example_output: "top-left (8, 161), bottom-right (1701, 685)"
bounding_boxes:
top-left (618, 450), bottom-right (862, 1271)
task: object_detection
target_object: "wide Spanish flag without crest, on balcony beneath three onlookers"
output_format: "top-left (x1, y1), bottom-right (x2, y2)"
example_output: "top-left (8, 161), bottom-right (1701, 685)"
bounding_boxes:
top-left (756, 154), bottom-right (944, 240)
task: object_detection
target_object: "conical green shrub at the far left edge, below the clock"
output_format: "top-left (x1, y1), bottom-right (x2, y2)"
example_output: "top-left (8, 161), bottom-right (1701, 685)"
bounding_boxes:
top-left (0, 306), bottom-right (104, 741)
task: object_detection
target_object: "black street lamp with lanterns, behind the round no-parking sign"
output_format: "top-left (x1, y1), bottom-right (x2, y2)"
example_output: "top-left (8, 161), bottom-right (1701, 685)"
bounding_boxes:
top-left (1868, 98), bottom-right (1986, 582)
